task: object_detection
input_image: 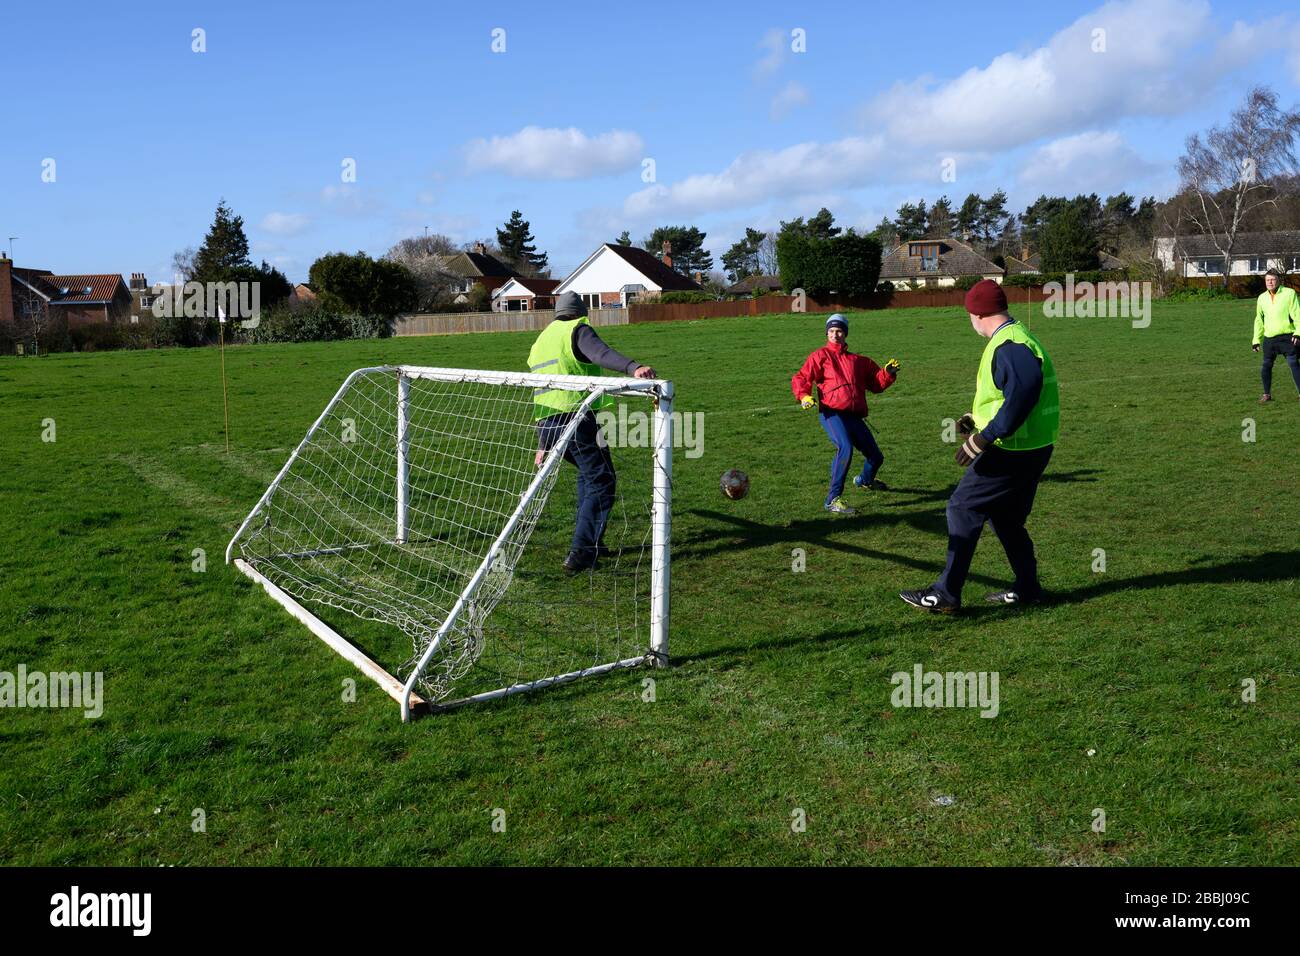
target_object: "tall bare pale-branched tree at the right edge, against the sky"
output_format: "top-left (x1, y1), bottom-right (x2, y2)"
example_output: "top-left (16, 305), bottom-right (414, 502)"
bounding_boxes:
top-left (1178, 86), bottom-right (1300, 285)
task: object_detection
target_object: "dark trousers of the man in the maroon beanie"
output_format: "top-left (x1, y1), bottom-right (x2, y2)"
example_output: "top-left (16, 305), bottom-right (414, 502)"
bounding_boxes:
top-left (935, 445), bottom-right (1053, 604)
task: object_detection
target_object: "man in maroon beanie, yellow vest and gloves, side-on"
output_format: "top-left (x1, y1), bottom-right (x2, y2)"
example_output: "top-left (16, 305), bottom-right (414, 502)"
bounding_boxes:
top-left (898, 278), bottom-right (1061, 614)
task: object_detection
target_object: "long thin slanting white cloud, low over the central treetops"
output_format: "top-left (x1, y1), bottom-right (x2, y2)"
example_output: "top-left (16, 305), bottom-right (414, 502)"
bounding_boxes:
top-left (623, 137), bottom-right (888, 221)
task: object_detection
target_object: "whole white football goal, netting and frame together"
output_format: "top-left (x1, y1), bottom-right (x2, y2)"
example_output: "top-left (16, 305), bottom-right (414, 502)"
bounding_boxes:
top-left (226, 365), bottom-right (673, 719)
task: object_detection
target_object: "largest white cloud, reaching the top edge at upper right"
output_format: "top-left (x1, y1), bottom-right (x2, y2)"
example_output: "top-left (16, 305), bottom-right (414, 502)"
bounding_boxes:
top-left (865, 0), bottom-right (1216, 150)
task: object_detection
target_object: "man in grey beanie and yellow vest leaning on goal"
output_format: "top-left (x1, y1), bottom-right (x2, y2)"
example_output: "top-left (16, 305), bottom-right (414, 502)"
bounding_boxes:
top-left (528, 293), bottom-right (655, 574)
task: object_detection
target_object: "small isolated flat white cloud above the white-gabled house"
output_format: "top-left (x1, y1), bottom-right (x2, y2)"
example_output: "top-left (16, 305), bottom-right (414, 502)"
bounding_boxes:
top-left (465, 126), bottom-right (645, 179)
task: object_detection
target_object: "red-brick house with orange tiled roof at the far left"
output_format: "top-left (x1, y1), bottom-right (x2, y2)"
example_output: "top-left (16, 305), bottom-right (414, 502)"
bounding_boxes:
top-left (0, 255), bottom-right (134, 328)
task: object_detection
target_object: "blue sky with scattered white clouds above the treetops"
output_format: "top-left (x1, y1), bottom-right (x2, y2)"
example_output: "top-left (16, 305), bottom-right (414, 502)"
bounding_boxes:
top-left (0, 0), bottom-right (1300, 282)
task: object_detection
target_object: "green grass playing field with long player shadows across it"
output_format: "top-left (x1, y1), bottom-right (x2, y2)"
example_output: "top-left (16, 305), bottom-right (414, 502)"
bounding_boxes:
top-left (0, 303), bottom-right (1300, 865)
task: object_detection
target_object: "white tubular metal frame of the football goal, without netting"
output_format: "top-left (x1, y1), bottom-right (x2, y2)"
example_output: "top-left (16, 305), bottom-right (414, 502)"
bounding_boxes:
top-left (226, 365), bottom-right (673, 722)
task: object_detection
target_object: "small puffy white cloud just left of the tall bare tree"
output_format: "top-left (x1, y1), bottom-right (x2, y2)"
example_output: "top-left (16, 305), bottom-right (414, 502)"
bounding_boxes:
top-left (1019, 130), bottom-right (1164, 195)
